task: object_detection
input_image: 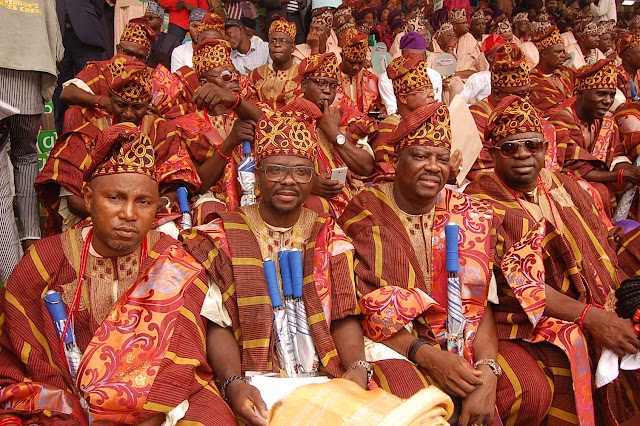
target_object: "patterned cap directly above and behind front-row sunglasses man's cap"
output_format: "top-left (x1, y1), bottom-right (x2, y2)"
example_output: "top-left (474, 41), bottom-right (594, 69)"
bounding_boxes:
top-left (491, 43), bottom-right (531, 87)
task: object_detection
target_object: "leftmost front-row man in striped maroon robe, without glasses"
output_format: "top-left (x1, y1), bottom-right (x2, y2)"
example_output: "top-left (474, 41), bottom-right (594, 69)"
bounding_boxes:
top-left (0, 123), bottom-right (235, 425)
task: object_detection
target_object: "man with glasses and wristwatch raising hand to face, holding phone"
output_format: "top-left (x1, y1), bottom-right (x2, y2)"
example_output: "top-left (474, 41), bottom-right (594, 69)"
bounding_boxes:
top-left (299, 53), bottom-right (377, 217)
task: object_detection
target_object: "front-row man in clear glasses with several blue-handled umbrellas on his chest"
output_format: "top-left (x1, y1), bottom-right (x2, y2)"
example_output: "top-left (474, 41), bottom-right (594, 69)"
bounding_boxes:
top-left (181, 99), bottom-right (373, 424)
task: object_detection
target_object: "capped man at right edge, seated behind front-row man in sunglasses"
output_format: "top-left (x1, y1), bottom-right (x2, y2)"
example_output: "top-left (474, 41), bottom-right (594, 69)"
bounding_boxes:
top-left (549, 59), bottom-right (640, 218)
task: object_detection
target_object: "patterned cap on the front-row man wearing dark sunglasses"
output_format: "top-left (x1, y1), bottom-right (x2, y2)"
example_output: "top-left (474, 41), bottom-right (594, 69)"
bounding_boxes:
top-left (484, 95), bottom-right (542, 146)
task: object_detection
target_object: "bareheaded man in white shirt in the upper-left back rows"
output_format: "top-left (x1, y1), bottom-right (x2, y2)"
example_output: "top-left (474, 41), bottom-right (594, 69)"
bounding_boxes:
top-left (225, 19), bottom-right (271, 75)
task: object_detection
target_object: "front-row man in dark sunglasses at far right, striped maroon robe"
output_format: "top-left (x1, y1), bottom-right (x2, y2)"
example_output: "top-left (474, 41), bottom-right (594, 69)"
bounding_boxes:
top-left (465, 96), bottom-right (640, 424)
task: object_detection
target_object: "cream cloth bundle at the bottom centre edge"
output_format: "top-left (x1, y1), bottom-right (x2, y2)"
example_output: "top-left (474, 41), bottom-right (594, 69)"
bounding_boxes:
top-left (269, 379), bottom-right (453, 426)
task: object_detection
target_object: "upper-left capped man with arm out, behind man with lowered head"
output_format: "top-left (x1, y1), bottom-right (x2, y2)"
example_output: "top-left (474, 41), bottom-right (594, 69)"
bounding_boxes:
top-left (60, 18), bottom-right (157, 133)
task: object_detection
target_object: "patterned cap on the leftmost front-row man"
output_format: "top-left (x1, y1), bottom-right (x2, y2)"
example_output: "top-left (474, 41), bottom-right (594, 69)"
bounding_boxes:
top-left (83, 123), bottom-right (157, 182)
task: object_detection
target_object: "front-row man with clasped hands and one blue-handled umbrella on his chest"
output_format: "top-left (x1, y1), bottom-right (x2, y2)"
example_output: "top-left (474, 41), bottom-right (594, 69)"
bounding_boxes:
top-left (339, 103), bottom-right (501, 424)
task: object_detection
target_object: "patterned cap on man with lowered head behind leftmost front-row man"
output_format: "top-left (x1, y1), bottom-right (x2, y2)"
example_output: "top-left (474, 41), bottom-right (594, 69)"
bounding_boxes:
top-left (105, 55), bottom-right (152, 103)
